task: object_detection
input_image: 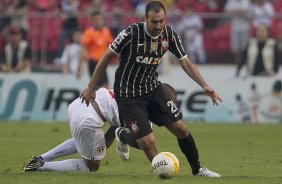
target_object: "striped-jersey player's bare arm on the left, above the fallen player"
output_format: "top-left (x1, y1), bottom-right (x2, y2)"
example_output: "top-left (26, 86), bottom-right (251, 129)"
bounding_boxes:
top-left (80, 48), bottom-right (114, 106)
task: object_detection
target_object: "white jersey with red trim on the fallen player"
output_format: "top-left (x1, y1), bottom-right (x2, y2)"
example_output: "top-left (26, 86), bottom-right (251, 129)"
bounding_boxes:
top-left (95, 88), bottom-right (121, 127)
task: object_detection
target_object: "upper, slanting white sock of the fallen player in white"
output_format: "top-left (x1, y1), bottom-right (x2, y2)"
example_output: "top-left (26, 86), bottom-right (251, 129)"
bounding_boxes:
top-left (40, 138), bottom-right (77, 162)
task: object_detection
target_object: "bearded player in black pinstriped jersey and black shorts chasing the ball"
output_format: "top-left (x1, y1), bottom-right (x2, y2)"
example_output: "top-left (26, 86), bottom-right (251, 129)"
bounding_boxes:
top-left (81, 1), bottom-right (221, 177)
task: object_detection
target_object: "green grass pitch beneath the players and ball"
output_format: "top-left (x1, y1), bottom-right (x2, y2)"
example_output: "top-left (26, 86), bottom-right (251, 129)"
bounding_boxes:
top-left (0, 121), bottom-right (282, 184)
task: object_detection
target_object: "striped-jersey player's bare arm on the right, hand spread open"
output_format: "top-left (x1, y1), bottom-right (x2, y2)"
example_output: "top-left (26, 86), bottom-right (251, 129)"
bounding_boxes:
top-left (180, 58), bottom-right (222, 105)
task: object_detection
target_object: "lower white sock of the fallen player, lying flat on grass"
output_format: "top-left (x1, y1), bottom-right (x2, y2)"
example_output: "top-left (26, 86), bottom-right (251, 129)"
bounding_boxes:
top-left (37, 159), bottom-right (90, 172)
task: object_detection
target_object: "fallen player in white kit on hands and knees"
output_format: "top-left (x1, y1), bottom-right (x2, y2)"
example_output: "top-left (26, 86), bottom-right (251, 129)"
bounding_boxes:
top-left (23, 88), bottom-right (129, 171)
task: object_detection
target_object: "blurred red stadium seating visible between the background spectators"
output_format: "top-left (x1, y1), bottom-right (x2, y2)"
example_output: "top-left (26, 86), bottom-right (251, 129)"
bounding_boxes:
top-left (0, 0), bottom-right (282, 68)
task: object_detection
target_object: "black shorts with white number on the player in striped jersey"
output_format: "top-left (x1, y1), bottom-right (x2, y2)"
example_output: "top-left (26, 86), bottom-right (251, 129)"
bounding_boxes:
top-left (116, 85), bottom-right (182, 139)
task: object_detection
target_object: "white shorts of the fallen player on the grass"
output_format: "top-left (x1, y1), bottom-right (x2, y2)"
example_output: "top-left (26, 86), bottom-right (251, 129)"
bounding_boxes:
top-left (68, 99), bottom-right (106, 160)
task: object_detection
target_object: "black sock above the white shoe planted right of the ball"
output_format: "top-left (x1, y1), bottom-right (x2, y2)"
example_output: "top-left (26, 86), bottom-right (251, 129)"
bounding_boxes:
top-left (177, 134), bottom-right (201, 174)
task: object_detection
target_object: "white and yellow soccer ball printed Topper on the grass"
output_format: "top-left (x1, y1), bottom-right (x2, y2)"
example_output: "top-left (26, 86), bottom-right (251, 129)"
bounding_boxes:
top-left (151, 152), bottom-right (179, 179)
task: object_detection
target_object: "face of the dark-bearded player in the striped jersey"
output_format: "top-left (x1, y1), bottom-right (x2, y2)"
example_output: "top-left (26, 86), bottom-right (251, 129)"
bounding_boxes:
top-left (145, 9), bottom-right (166, 36)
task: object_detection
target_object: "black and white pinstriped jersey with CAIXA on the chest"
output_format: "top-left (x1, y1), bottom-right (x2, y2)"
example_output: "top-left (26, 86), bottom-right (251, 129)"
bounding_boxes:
top-left (109, 22), bottom-right (187, 97)
